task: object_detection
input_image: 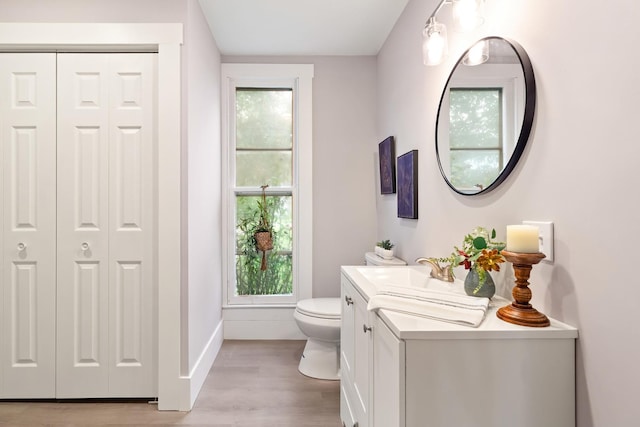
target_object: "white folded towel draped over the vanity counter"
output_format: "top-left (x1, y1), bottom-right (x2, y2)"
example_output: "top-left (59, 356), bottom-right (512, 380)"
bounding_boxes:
top-left (367, 286), bottom-right (489, 327)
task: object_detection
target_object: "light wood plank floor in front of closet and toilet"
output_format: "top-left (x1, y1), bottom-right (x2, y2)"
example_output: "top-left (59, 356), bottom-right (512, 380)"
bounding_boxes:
top-left (0, 341), bottom-right (342, 427)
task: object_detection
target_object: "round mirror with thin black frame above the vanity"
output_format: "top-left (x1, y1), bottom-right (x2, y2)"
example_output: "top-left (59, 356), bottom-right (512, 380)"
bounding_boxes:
top-left (436, 37), bottom-right (536, 195)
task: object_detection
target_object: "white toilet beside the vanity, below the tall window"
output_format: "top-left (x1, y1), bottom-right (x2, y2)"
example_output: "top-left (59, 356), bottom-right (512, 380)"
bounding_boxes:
top-left (293, 252), bottom-right (407, 380)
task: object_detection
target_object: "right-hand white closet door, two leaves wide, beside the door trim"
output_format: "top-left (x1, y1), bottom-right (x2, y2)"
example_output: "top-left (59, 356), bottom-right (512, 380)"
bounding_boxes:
top-left (56, 54), bottom-right (157, 398)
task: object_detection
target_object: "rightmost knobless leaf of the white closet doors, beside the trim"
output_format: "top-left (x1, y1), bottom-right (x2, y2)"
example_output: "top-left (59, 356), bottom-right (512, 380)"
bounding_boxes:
top-left (109, 54), bottom-right (157, 396)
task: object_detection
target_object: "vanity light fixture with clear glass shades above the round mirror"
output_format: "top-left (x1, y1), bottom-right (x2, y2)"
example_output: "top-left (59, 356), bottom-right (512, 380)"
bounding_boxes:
top-left (422, 0), bottom-right (488, 65)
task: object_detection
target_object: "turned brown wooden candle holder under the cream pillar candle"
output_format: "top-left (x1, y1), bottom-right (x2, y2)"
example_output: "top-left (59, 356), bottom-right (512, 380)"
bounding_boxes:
top-left (496, 250), bottom-right (550, 327)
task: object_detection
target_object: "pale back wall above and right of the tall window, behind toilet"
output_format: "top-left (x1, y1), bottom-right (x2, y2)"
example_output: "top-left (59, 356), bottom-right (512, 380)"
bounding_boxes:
top-left (222, 56), bottom-right (377, 297)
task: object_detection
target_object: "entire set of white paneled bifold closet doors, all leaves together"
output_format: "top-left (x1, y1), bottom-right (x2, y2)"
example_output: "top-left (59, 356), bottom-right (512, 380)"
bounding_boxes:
top-left (0, 53), bottom-right (157, 398)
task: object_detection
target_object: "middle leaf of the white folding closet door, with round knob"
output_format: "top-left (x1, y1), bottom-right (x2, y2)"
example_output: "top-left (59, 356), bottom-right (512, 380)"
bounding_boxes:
top-left (57, 54), bottom-right (109, 398)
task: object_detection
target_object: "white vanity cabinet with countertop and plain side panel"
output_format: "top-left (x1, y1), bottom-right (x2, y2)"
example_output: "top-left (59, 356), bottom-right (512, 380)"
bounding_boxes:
top-left (341, 266), bottom-right (578, 427)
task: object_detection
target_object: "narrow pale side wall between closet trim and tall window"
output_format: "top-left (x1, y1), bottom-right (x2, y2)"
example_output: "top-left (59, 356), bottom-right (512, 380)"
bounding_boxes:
top-left (182, 0), bottom-right (222, 398)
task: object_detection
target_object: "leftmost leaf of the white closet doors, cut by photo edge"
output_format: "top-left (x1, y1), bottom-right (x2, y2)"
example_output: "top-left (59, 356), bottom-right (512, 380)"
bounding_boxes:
top-left (0, 54), bottom-right (56, 398)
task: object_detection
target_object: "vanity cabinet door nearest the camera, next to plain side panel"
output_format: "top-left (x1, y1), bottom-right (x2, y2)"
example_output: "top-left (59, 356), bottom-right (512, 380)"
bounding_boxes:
top-left (371, 316), bottom-right (405, 427)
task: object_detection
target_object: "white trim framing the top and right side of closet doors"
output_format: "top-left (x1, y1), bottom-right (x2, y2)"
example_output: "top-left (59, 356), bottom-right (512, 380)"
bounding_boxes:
top-left (0, 23), bottom-right (185, 411)
